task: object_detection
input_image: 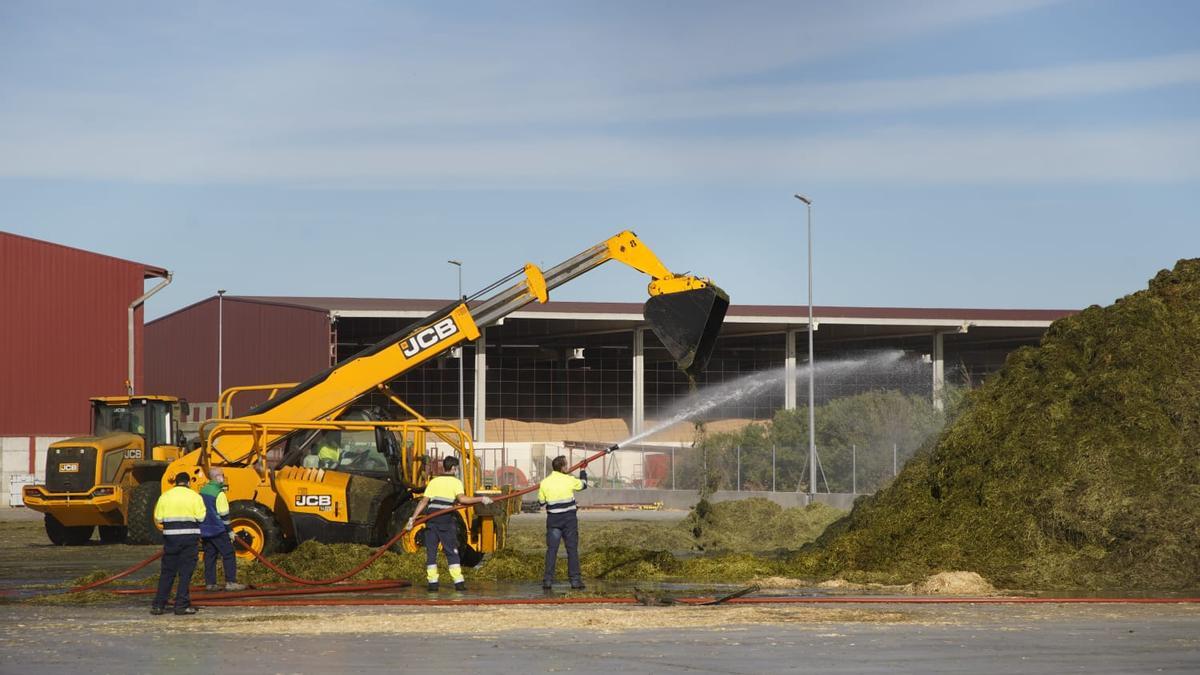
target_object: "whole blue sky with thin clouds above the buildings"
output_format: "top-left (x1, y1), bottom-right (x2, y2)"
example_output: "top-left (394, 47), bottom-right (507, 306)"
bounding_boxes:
top-left (0, 0), bottom-right (1200, 317)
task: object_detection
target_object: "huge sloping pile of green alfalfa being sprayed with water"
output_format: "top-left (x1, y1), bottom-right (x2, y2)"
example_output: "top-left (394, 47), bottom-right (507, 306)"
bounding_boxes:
top-left (794, 259), bottom-right (1200, 590)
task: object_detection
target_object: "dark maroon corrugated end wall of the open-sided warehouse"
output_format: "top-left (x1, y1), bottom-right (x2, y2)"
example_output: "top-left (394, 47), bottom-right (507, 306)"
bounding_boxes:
top-left (145, 295), bottom-right (330, 414)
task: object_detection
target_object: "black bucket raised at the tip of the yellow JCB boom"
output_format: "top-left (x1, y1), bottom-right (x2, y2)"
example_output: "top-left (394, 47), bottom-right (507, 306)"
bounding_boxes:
top-left (642, 285), bottom-right (730, 380)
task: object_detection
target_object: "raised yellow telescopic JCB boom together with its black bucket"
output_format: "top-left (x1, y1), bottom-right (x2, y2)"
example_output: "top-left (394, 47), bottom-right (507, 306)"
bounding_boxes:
top-left (204, 231), bottom-right (728, 458)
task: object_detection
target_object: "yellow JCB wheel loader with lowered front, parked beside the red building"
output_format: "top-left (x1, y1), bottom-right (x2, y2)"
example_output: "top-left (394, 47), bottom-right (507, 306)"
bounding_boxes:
top-left (22, 395), bottom-right (188, 545)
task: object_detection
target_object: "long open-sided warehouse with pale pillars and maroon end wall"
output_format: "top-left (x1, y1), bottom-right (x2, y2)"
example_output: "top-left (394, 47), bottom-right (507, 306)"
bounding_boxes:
top-left (146, 295), bottom-right (1070, 487)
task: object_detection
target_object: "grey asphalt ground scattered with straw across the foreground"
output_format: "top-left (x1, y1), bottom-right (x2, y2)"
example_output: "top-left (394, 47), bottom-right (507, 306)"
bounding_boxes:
top-left (0, 512), bottom-right (1200, 674)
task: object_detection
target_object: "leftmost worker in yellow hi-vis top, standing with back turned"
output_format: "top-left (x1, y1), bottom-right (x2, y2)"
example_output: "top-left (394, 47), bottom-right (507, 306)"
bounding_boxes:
top-left (150, 472), bottom-right (208, 614)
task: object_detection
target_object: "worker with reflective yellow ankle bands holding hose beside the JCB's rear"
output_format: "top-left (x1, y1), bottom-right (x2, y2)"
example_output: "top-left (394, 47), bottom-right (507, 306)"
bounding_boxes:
top-left (404, 456), bottom-right (492, 591)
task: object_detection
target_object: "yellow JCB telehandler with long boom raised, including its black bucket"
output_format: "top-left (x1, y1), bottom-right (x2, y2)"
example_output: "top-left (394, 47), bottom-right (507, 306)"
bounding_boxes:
top-left (162, 231), bottom-right (728, 566)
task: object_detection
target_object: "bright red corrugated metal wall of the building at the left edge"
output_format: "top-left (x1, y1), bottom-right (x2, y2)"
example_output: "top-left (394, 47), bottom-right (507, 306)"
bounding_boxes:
top-left (0, 232), bottom-right (145, 436)
